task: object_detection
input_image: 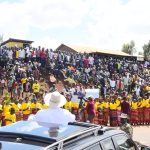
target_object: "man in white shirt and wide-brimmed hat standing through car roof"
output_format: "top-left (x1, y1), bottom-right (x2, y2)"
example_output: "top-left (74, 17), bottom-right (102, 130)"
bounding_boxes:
top-left (34, 91), bottom-right (75, 128)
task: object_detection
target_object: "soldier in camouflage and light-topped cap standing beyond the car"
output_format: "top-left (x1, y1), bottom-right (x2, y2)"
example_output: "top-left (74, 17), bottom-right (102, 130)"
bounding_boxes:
top-left (120, 113), bottom-right (133, 138)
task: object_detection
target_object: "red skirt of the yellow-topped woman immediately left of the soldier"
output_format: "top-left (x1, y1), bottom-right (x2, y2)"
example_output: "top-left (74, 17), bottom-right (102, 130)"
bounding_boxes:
top-left (110, 110), bottom-right (118, 127)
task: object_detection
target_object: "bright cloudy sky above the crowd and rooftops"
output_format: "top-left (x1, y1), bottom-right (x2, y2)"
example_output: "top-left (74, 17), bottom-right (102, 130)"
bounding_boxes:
top-left (0, 0), bottom-right (150, 51)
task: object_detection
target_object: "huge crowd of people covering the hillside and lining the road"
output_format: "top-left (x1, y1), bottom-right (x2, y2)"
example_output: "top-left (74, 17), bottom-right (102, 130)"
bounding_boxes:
top-left (0, 47), bottom-right (150, 126)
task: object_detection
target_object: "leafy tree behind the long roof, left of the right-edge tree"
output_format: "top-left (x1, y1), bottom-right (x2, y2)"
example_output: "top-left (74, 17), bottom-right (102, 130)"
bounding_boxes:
top-left (122, 41), bottom-right (136, 55)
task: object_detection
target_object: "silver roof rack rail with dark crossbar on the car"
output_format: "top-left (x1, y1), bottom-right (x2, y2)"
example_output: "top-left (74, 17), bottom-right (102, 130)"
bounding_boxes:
top-left (44, 122), bottom-right (104, 150)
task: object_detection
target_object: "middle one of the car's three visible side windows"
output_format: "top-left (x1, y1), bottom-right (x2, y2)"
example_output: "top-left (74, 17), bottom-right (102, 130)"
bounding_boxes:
top-left (101, 138), bottom-right (115, 150)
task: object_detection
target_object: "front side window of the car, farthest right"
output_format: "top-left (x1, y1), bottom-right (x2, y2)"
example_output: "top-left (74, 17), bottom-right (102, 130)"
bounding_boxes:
top-left (113, 135), bottom-right (136, 150)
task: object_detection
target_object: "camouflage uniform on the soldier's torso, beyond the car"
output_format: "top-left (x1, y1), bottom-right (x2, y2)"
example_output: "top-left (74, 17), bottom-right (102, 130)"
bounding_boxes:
top-left (120, 123), bottom-right (133, 138)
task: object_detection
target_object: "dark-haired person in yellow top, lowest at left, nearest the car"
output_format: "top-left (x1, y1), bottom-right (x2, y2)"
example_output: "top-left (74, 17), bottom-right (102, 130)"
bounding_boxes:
top-left (4, 108), bottom-right (16, 125)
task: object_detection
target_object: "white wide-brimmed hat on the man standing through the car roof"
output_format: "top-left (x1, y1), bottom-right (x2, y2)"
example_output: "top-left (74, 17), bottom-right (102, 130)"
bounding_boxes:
top-left (44, 91), bottom-right (66, 108)
